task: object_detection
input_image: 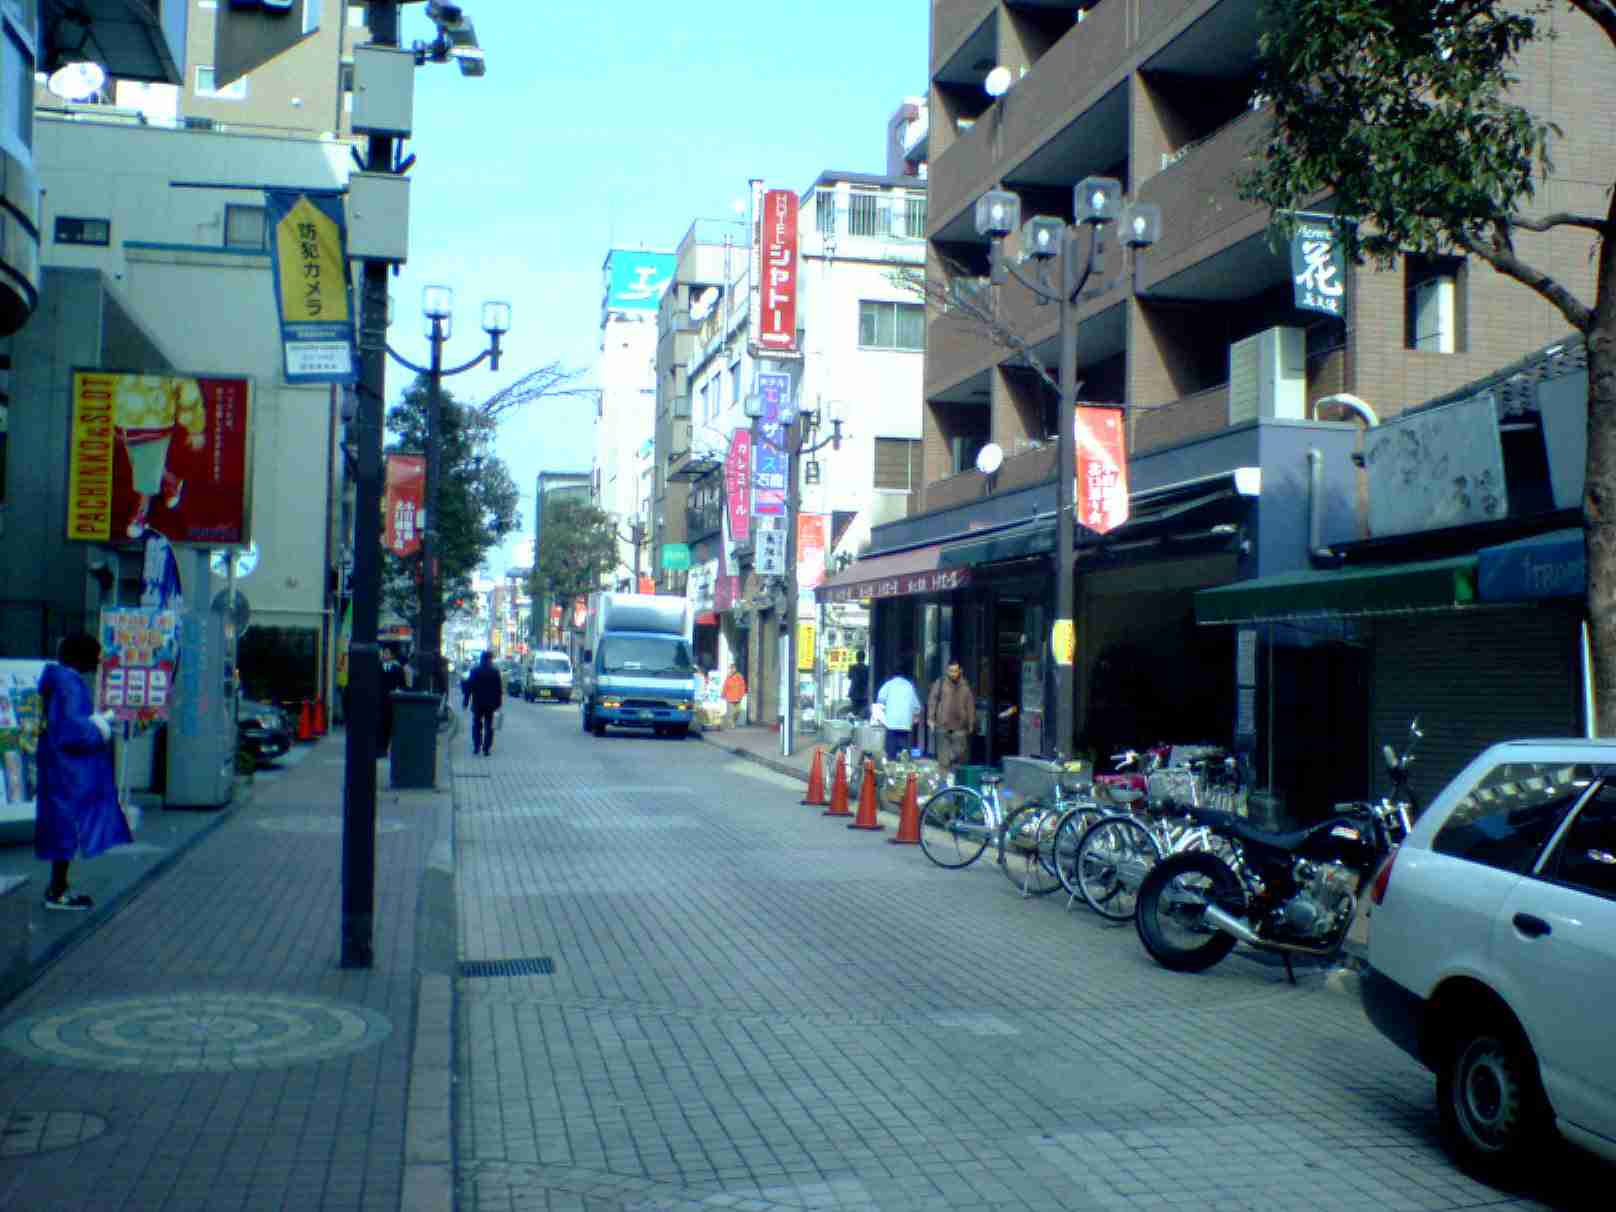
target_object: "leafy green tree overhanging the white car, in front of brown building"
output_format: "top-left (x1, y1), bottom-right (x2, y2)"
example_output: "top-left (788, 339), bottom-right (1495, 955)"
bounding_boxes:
top-left (1239, 0), bottom-right (1616, 735)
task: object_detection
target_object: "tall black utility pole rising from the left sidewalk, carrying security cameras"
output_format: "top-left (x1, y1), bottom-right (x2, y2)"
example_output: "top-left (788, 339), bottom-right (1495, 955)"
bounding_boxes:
top-left (341, 0), bottom-right (399, 968)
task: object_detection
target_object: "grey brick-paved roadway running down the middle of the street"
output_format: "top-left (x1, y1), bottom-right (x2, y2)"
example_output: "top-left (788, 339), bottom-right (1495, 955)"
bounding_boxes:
top-left (454, 705), bottom-right (1613, 1212)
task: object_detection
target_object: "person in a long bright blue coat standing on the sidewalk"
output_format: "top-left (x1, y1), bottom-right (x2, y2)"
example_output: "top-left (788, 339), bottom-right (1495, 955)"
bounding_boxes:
top-left (34, 632), bottom-right (134, 911)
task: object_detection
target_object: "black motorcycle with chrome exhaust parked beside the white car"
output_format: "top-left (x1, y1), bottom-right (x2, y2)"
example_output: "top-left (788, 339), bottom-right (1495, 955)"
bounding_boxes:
top-left (1134, 719), bottom-right (1422, 983)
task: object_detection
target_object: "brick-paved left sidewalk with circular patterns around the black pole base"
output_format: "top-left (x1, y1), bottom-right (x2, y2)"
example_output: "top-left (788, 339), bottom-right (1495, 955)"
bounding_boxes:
top-left (0, 734), bottom-right (456, 1212)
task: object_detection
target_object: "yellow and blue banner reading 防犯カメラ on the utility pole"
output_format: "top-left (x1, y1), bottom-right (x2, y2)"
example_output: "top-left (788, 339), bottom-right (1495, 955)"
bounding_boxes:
top-left (263, 189), bottom-right (354, 383)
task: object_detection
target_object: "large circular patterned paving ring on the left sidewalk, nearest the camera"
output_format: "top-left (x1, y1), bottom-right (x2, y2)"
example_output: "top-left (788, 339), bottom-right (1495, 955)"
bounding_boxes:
top-left (0, 994), bottom-right (393, 1073)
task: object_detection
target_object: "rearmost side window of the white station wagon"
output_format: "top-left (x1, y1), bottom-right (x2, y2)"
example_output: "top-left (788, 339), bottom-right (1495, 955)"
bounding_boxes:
top-left (1430, 763), bottom-right (1593, 874)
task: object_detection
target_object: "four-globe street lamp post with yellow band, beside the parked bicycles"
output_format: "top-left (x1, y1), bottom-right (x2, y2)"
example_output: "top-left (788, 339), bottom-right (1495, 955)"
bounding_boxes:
top-left (976, 176), bottom-right (1162, 760)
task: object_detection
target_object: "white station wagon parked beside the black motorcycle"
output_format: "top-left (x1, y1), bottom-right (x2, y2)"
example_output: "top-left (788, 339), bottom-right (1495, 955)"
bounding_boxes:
top-left (1362, 740), bottom-right (1616, 1175)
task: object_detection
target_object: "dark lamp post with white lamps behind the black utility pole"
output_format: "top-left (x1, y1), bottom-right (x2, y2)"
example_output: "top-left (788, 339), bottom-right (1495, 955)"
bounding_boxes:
top-left (386, 286), bottom-right (511, 693)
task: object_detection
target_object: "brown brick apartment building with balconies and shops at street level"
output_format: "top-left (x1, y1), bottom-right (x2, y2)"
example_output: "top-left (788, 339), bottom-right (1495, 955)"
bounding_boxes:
top-left (850, 0), bottom-right (1616, 817)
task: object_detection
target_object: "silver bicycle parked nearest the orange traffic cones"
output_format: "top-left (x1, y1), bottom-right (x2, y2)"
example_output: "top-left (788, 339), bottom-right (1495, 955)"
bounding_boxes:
top-left (920, 774), bottom-right (1062, 897)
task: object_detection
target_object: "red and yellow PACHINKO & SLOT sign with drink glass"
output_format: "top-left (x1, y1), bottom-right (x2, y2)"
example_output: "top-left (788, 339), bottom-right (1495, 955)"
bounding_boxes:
top-left (66, 370), bottom-right (252, 548)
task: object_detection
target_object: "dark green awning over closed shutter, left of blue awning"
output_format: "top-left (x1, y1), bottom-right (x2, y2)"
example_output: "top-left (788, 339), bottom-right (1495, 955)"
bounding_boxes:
top-left (1196, 556), bottom-right (1475, 624)
